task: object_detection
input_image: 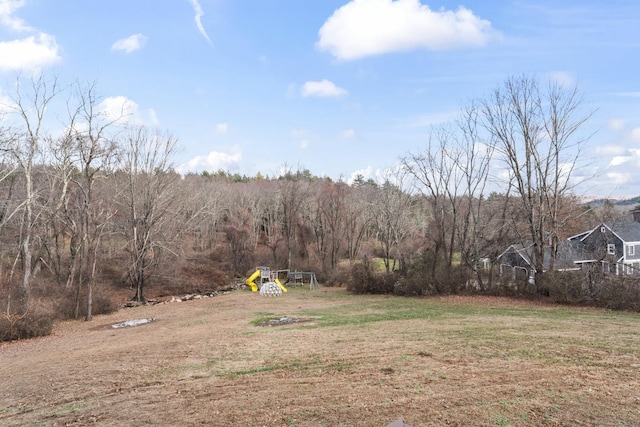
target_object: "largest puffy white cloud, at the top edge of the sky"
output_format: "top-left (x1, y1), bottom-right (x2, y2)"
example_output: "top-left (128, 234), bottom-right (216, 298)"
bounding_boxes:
top-left (316, 0), bottom-right (499, 60)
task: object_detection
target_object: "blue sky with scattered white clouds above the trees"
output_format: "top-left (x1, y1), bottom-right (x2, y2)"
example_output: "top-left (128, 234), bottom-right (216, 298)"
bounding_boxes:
top-left (0, 0), bottom-right (640, 197)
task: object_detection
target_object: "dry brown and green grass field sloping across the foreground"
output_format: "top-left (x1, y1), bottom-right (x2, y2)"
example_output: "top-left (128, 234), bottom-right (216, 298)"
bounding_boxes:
top-left (0, 288), bottom-right (640, 427)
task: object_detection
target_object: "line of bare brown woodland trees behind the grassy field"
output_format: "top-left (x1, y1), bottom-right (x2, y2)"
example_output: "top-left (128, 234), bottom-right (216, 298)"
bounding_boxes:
top-left (0, 75), bottom-right (632, 338)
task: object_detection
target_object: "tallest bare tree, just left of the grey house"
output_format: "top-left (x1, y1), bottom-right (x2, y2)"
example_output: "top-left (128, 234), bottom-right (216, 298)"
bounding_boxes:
top-left (481, 76), bottom-right (591, 286)
